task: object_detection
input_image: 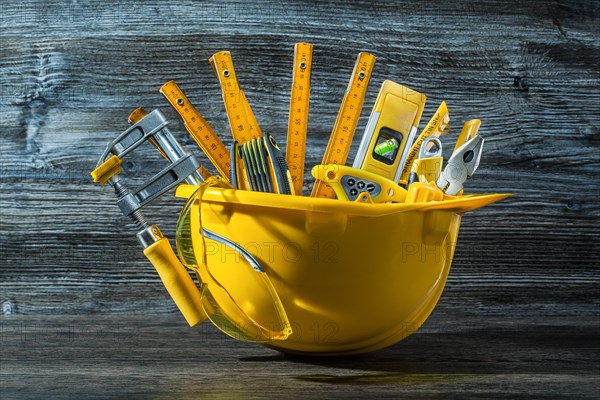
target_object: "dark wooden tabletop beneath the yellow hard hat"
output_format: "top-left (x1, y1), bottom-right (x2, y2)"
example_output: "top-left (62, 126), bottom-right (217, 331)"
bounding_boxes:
top-left (0, 314), bottom-right (600, 400)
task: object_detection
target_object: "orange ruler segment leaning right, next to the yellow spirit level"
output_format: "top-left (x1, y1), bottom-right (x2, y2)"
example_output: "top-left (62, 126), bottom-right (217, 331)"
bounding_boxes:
top-left (311, 52), bottom-right (376, 199)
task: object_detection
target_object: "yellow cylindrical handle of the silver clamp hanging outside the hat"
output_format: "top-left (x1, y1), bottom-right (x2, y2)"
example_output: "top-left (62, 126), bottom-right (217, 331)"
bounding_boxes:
top-left (144, 237), bottom-right (207, 326)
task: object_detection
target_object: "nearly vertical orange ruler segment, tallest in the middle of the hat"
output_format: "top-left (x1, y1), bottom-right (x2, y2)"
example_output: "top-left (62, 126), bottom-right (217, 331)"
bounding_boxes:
top-left (285, 43), bottom-right (313, 195)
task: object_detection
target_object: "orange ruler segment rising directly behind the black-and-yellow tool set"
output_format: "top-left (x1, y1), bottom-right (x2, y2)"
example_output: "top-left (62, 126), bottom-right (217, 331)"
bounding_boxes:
top-left (209, 51), bottom-right (262, 144)
